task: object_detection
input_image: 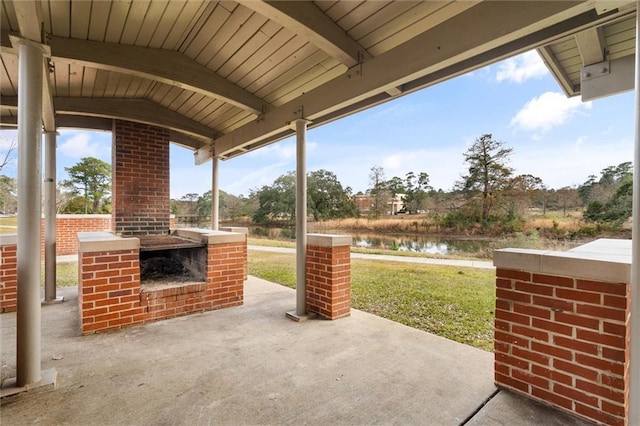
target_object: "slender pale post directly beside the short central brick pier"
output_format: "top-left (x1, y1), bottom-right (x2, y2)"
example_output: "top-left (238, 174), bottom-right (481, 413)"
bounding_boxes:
top-left (295, 119), bottom-right (307, 317)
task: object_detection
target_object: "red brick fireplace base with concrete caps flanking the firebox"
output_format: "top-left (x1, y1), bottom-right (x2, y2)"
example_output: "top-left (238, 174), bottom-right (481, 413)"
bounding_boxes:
top-left (78, 230), bottom-right (246, 334)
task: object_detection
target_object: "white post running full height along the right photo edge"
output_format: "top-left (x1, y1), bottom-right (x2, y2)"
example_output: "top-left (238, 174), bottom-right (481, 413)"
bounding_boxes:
top-left (627, 4), bottom-right (640, 425)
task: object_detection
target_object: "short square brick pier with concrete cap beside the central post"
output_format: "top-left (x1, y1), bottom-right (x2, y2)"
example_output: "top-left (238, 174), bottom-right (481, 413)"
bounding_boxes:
top-left (306, 234), bottom-right (351, 320)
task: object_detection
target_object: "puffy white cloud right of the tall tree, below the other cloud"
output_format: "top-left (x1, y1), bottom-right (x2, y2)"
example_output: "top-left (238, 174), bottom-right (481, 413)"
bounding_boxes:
top-left (511, 92), bottom-right (591, 132)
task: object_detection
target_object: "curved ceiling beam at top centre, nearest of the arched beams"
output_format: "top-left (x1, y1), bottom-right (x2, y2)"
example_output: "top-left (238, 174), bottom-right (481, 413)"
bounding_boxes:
top-left (242, 0), bottom-right (371, 68)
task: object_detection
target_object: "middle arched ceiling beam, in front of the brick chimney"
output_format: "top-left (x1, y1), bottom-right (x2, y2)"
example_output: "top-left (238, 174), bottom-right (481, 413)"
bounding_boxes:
top-left (49, 37), bottom-right (268, 115)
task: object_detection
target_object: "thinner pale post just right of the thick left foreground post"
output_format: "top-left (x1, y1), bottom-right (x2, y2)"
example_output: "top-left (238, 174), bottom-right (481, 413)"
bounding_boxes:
top-left (44, 131), bottom-right (64, 304)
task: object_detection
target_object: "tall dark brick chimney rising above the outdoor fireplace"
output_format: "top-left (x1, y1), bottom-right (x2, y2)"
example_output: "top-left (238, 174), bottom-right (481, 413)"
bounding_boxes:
top-left (111, 120), bottom-right (170, 236)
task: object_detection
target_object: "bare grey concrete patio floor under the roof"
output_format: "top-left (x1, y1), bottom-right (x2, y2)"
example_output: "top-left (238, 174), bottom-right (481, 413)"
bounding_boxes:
top-left (0, 277), bottom-right (587, 425)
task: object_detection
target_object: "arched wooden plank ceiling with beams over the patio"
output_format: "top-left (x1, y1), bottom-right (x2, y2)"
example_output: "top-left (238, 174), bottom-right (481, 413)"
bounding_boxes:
top-left (0, 0), bottom-right (635, 160)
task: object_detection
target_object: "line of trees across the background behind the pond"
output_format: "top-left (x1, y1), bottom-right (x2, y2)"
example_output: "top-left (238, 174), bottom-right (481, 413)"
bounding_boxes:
top-left (0, 134), bottom-right (633, 236)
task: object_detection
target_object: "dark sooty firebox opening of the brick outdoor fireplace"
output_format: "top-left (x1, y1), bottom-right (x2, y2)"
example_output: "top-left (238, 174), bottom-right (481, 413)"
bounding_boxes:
top-left (140, 236), bottom-right (207, 285)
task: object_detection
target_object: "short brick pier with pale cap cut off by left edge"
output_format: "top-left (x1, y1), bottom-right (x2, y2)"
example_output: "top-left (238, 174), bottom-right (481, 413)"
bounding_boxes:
top-left (0, 234), bottom-right (18, 313)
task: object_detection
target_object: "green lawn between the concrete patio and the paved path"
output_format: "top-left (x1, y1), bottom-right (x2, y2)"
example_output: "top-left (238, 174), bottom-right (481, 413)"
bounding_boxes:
top-left (249, 251), bottom-right (495, 351)
